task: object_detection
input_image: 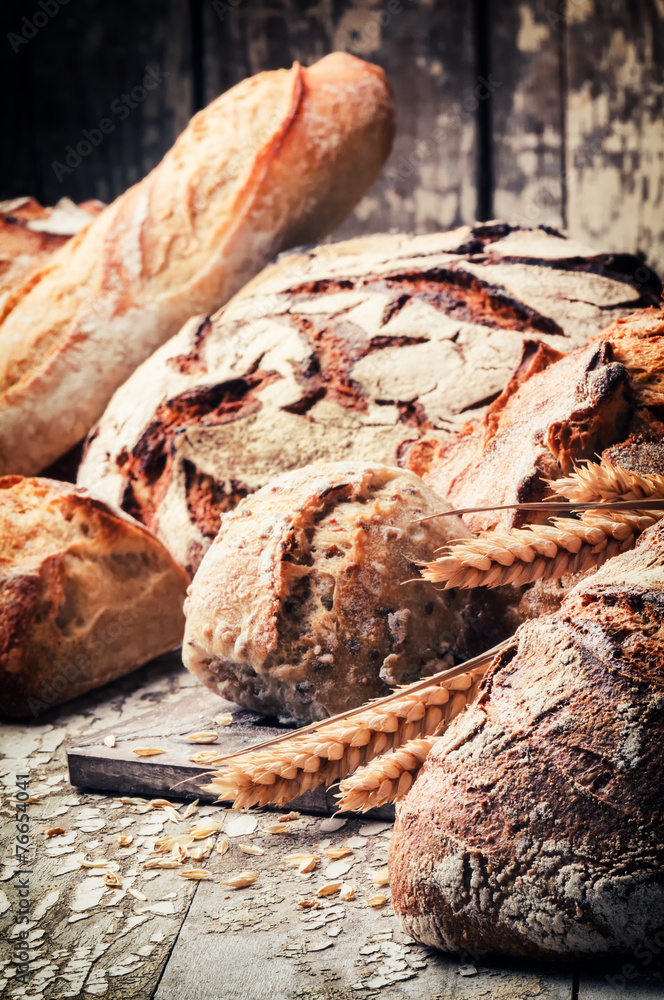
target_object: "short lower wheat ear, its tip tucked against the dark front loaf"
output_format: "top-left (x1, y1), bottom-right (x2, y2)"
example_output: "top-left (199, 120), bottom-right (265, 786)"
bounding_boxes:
top-left (339, 736), bottom-right (440, 812)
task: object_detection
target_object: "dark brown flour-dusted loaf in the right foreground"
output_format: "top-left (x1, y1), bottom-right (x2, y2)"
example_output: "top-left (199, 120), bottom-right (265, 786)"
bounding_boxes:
top-left (389, 520), bottom-right (664, 959)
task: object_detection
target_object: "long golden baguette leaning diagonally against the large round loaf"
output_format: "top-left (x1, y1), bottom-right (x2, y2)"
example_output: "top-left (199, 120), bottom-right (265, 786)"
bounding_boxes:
top-left (0, 53), bottom-right (394, 474)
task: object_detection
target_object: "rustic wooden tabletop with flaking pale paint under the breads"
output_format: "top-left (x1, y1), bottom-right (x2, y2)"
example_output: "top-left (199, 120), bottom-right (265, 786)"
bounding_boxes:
top-left (0, 662), bottom-right (664, 1000)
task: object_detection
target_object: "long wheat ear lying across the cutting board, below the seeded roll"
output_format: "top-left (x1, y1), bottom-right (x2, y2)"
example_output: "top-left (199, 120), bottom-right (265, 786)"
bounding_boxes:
top-left (205, 642), bottom-right (500, 809)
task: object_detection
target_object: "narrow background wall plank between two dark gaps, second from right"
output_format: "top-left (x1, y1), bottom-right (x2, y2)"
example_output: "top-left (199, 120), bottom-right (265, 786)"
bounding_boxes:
top-left (486, 0), bottom-right (564, 226)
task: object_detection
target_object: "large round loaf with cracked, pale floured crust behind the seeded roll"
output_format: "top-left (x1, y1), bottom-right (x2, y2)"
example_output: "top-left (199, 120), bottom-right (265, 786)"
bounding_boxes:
top-left (79, 223), bottom-right (659, 572)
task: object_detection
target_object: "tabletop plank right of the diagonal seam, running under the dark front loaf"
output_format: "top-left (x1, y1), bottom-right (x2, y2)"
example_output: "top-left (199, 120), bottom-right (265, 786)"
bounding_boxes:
top-left (155, 818), bottom-right (572, 1000)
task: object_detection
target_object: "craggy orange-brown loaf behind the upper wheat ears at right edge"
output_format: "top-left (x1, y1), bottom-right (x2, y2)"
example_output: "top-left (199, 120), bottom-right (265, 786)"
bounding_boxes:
top-left (416, 308), bottom-right (664, 531)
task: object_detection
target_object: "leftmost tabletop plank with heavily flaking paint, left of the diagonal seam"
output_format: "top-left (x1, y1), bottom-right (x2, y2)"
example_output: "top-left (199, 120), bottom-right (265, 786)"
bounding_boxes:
top-left (0, 668), bottom-right (205, 1000)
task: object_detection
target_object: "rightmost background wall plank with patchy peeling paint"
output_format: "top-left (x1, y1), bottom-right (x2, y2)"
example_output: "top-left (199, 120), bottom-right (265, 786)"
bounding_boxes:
top-left (566, 0), bottom-right (664, 267)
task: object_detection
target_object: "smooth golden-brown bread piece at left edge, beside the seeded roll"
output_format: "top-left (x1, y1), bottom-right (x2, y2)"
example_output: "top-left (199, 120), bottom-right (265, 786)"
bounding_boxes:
top-left (0, 476), bottom-right (187, 717)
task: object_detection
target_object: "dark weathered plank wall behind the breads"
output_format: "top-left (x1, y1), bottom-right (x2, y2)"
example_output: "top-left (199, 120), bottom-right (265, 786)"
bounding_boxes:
top-left (0, 0), bottom-right (664, 270)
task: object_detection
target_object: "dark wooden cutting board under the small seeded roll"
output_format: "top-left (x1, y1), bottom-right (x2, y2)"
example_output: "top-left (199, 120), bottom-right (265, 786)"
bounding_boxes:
top-left (67, 688), bottom-right (394, 820)
